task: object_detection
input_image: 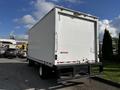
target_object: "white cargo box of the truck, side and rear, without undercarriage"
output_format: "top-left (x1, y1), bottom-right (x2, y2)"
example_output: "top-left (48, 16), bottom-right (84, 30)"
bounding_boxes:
top-left (28, 8), bottom-right (97, 65)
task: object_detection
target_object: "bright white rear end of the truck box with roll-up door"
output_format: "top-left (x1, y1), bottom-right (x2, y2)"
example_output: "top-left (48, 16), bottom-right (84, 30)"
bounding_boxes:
top-left (55, 7), bottom-right (97, 65)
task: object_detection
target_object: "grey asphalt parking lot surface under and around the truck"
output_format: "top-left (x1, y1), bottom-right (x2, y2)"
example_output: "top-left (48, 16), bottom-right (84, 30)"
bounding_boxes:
top-left (0, 58), bottom-right (120, 90)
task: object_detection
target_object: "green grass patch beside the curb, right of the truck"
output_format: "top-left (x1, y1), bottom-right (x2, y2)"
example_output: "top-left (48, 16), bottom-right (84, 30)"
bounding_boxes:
top-left (103, 63), bottom-right (120, 83)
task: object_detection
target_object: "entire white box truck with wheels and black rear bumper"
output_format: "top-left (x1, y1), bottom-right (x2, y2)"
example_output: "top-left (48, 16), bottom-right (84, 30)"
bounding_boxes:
top-left (27, 7), bottom-right (101, 78)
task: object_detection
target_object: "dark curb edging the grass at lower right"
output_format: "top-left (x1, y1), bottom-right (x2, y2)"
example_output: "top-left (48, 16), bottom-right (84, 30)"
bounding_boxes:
top-left (91, 77), bottom-right (120, 88)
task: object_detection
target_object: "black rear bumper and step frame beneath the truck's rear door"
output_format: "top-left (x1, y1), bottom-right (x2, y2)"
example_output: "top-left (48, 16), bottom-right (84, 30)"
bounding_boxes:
top-left (56, 62), bottom-right (103, 77)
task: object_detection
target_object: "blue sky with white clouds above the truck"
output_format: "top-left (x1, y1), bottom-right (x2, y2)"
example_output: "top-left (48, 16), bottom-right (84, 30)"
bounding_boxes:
top-left (0, 0), bottom-right (120, 37)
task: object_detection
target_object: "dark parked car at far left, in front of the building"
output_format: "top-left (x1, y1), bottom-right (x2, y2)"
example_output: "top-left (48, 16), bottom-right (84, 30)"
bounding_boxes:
top-left (4, 48), bottom-right (17, 58)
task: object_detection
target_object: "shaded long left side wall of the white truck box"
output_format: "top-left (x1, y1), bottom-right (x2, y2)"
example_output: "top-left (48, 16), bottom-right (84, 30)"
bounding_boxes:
top-left (28, 11), bottom-right (55, 64)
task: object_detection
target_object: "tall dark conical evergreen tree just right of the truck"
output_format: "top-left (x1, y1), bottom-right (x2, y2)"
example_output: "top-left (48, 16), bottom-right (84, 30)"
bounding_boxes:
top-left (102, 29), bottom-right (113, 61)
